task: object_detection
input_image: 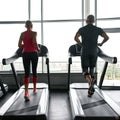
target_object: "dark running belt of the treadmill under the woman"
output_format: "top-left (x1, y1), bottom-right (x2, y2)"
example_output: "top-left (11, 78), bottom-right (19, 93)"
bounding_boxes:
top-left (5, 89), bottom-right (42, 116)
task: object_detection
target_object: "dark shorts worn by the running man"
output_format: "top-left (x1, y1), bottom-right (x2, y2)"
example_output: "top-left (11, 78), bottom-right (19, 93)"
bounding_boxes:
top-left (81, 55), bottom-right (97, 68)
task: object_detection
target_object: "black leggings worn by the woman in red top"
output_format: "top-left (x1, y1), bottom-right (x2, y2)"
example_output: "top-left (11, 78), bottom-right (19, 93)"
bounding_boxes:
top-left (23, 52), bottom-right (38, 78)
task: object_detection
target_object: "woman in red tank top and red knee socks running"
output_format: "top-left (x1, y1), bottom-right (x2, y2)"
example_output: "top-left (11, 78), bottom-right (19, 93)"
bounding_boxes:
top-left (18, 20), bottom-right (40, 101)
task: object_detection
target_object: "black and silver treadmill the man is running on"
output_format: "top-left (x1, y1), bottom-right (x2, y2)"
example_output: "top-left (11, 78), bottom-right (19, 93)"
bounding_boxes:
top-left (68, 44), bottom-right (120, 120)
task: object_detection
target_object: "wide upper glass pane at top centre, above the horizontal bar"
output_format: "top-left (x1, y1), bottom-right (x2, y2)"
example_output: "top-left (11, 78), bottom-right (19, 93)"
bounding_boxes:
top-left (43, 0), bottom-right (82, 20)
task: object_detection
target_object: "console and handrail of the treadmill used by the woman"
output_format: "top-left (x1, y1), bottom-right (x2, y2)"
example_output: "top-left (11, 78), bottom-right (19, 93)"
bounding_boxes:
top-left (2, 44), bottom-right (48, 65)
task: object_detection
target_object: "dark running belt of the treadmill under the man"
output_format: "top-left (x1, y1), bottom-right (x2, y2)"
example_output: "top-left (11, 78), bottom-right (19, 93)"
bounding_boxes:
top-left (76, 89), bottom-right (117, 118)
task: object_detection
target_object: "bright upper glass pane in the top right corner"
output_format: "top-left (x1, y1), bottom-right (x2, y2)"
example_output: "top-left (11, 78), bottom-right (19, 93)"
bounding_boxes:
top-left (97, 0), bottom-right (120, 18)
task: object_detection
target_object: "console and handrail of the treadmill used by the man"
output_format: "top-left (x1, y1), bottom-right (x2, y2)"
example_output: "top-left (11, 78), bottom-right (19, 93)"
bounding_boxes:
top-left (68, 44), bottom-right (117, 64)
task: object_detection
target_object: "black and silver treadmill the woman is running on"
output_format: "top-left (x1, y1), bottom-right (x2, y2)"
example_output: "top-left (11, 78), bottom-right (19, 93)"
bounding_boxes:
top-left (0, 44), bottom-right (50, 120)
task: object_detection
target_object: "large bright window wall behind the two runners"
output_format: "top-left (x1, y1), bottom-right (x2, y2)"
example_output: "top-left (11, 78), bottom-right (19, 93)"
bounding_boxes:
top-left (0, 0), bottom-right (120, 85)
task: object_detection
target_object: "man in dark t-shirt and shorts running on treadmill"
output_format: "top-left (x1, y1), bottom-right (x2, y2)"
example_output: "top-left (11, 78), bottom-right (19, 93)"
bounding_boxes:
top-left (74, 15), bottom-right (109, 97)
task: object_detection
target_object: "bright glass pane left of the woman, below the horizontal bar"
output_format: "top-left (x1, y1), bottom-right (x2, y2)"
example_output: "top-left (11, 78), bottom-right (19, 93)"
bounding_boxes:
top-left (0, 24), bottom-right (24, 59)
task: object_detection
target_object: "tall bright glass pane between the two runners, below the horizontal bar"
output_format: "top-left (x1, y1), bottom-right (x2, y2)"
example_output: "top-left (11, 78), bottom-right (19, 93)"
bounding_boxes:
top-left (44, 22), bottom-right (81, 72)
